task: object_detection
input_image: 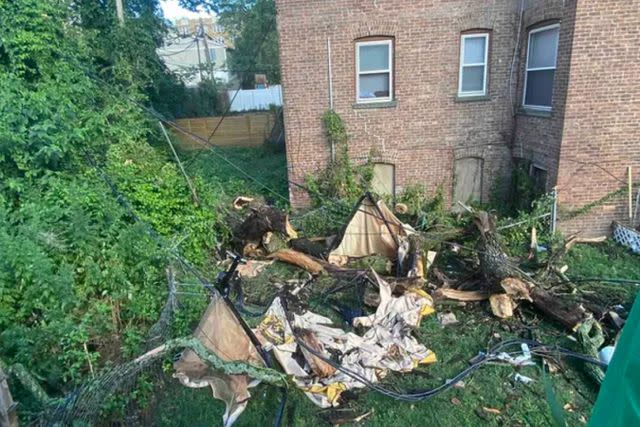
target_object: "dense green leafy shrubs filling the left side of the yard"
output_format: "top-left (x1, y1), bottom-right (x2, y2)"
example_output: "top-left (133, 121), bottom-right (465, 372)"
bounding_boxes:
top-left (0, 0), bottom-right (226, 418)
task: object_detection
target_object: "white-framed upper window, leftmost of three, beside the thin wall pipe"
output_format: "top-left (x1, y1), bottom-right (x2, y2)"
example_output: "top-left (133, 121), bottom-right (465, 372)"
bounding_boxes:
top-left (356, 40), bottom-right (393, 102)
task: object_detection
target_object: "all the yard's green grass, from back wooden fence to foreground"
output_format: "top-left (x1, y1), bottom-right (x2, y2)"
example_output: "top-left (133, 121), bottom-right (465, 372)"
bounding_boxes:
top-left (155, 148), bottom-right (640, 426)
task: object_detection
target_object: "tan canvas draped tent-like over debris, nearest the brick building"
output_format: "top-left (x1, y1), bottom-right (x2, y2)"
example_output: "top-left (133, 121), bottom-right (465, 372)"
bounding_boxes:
top-left (329, 194), bottom-right (413, 265)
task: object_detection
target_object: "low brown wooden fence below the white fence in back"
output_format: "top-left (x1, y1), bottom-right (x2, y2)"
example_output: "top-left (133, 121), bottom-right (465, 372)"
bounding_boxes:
top-left (173, 112), bottom-right (275, 150)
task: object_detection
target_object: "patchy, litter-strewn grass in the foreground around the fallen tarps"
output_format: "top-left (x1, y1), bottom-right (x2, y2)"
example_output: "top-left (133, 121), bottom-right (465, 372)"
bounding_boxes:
top-left (154, 263), bottom-right (597, 427)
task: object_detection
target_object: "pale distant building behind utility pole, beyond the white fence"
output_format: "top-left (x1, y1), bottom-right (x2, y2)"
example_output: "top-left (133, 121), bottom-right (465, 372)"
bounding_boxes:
top-left (158, 16), bottom-right (231, 86)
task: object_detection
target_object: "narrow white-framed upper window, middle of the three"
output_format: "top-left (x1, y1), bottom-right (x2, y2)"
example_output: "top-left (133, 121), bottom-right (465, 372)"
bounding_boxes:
top-left (458, 33), bottom-right (489, 96)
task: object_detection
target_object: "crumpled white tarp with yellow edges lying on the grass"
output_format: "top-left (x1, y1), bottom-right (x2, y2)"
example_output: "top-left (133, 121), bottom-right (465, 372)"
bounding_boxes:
top-left (256, 272), bottom-right (436, 408)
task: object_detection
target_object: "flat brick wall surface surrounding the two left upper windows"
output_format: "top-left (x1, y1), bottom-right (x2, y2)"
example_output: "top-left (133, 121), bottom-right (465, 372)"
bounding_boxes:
top-left (276, 0), bottom-right (519, 207)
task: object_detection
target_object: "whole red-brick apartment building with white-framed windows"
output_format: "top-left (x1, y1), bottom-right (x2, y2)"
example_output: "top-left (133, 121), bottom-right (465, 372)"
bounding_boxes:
top-left (276, 0), bottom-right (640, 234)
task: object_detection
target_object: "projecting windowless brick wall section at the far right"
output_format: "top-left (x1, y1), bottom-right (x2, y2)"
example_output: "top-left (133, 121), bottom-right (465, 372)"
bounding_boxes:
top-left (558, 0), bottom-right (640, 235)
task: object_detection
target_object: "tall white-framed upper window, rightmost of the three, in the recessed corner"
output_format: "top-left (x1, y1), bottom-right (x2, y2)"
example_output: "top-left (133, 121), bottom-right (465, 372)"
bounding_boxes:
top-left (523, 24), bottom-right (560, 110)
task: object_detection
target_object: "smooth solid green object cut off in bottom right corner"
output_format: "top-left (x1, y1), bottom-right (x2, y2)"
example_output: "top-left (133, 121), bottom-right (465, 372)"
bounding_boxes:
top-left (589, 294), bottom-right (640, 427)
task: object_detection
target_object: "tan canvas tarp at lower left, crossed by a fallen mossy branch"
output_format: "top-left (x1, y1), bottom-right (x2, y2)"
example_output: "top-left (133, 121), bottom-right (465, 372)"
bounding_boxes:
top-left (174, 297), bottom-right (265, 426)
